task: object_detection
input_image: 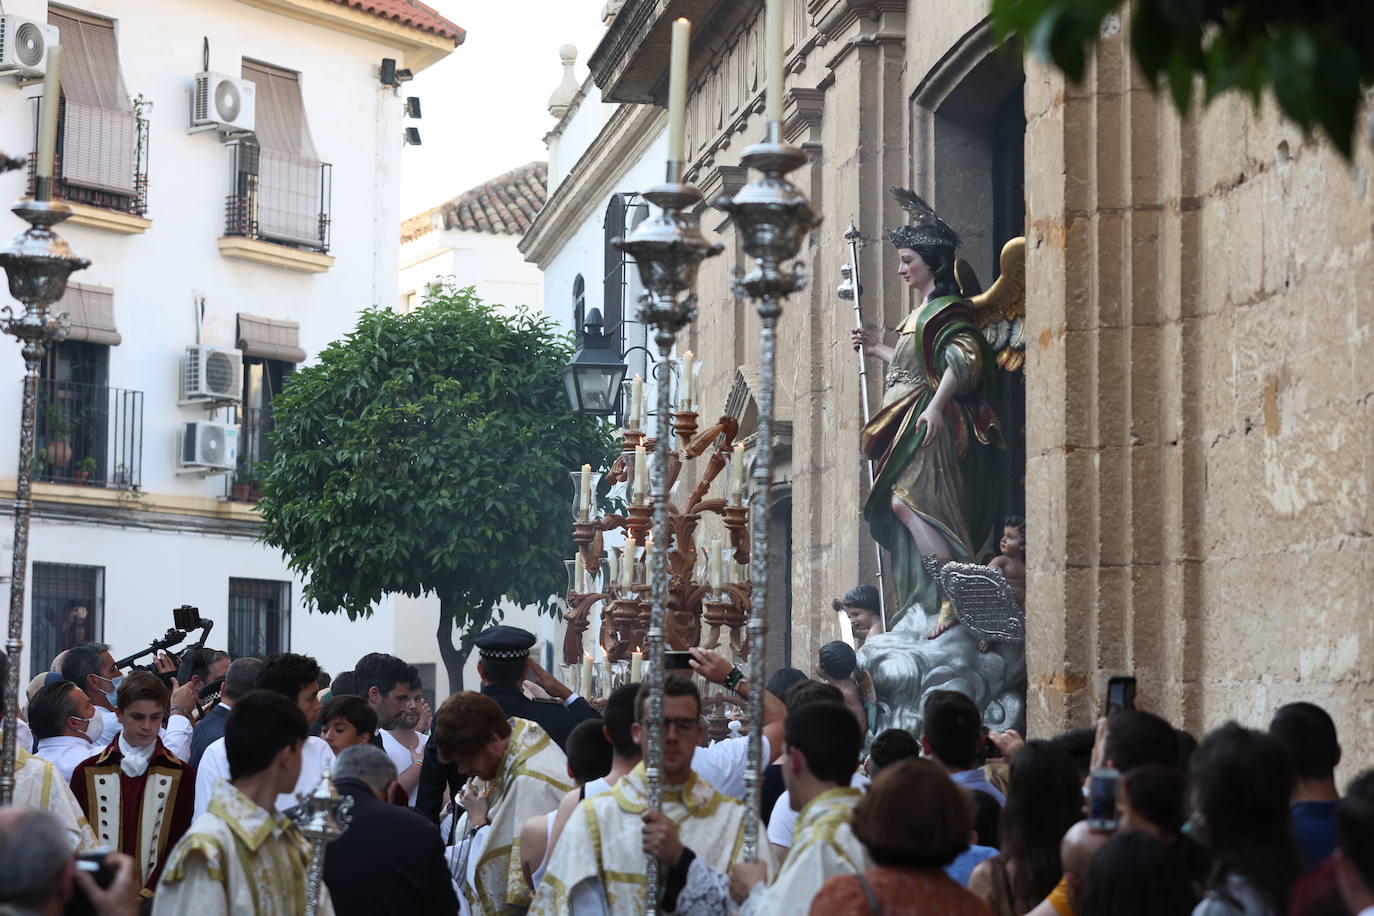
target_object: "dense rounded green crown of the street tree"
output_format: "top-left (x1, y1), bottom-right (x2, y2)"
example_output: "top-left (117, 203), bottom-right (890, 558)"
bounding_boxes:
top-left (257, 282), bottom-right (614, 641)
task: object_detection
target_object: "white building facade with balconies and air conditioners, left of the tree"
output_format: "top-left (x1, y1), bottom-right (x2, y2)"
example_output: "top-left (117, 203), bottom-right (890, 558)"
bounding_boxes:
top-left (0, 0), bottom-right (463, 685)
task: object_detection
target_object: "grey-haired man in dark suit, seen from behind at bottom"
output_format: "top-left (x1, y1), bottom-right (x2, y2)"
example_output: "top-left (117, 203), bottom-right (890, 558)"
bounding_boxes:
top-left (324, 744), bottom-right (458, 916)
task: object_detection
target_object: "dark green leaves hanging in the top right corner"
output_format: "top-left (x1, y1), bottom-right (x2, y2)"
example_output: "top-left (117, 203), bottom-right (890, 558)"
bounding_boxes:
top-left (992, 0), bottom-right (1374, 157)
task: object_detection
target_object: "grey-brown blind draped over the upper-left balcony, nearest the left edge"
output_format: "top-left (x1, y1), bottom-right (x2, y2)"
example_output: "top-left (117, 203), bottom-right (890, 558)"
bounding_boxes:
top-left (48, 8), bottom-right (139, 194)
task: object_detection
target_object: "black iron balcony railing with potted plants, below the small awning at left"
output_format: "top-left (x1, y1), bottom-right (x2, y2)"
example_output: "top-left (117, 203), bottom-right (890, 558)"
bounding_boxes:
top-left (33, 379), bottom-right (143, 490)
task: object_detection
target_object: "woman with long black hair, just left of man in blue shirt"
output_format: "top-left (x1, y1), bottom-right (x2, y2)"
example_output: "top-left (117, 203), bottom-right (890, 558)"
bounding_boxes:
top-left (1193, 722), bottom-right (1303, 916)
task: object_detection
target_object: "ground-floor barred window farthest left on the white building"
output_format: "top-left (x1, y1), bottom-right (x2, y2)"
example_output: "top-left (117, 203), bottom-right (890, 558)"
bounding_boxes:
top-left (29, 562), bottom-right (104, 673)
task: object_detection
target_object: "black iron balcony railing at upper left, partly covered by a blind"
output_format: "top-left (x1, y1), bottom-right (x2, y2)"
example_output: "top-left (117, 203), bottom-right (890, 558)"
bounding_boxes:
top-left (27, 99), bottom-right (148, 217)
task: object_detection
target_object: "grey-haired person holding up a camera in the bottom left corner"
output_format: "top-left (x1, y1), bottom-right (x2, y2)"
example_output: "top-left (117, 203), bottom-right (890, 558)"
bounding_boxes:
top-left (0, 808), bottom-right (139, 916)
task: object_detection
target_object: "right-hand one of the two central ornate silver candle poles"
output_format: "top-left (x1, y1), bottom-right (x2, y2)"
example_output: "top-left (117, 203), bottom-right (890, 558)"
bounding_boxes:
top-left (719, 121), bottom-right (819, 862)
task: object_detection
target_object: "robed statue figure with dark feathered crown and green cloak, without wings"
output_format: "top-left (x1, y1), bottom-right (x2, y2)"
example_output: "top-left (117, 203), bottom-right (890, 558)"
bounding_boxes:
top-left (852, 188), bottom-right (1002, 634)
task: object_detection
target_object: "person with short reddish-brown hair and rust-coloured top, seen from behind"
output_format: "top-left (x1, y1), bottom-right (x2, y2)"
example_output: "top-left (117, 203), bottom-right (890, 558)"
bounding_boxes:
top-left (811, 757), bottom-right (988, 916)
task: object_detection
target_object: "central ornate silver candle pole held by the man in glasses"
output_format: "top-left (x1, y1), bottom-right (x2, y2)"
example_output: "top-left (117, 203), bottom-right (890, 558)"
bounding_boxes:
top-left (611, 161), bottom-right (721, 916)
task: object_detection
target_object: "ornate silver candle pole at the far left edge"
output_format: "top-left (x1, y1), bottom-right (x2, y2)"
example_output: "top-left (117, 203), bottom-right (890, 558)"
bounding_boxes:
top-left (0, 200), bottom-right (91, 805)
